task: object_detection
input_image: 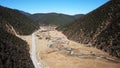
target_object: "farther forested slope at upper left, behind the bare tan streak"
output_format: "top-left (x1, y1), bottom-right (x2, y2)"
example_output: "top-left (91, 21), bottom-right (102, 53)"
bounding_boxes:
top-left (0, 6), bottom-right (38, 35)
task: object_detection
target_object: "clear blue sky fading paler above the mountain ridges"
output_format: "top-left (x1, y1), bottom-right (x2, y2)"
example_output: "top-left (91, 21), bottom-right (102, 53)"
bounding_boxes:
top-left (0, 0), bottom-right (109, 15)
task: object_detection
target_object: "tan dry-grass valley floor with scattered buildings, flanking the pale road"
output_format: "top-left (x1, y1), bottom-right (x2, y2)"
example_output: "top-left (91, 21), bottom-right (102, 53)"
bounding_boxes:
top-left (21, 26), bottom-right (120, 68)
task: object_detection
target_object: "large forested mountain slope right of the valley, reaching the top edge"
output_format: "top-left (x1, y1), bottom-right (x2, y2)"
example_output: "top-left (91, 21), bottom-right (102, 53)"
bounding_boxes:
top-left (57, 0), bottom-right (120, 57)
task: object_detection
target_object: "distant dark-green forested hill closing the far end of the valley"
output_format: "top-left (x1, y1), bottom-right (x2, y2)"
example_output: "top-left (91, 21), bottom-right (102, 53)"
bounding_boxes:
top-left (31, 13), bottom-right (82, 26)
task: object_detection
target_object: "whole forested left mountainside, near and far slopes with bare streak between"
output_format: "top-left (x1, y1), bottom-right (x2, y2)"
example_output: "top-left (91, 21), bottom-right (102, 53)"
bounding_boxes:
top-left (0, 6), bottom-right (38, 68)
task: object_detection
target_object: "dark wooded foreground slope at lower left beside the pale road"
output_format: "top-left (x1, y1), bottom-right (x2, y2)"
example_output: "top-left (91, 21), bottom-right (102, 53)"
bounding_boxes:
top-left (0, 28), bottom-right (34, 68)
